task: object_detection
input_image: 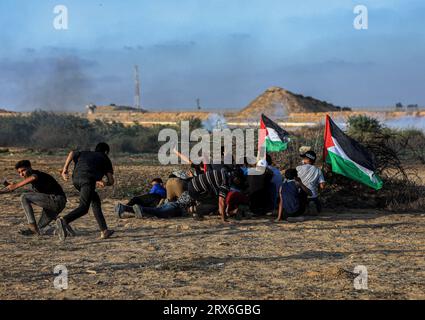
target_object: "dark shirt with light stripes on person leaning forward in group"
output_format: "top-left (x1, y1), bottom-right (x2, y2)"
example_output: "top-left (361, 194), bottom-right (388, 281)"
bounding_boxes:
top-left (188, 168), bottom-right (230, 198)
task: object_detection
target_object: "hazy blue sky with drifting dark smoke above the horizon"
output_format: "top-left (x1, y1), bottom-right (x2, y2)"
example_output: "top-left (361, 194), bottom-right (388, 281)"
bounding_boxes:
top-left (0, 0), bottom-right (425, 111)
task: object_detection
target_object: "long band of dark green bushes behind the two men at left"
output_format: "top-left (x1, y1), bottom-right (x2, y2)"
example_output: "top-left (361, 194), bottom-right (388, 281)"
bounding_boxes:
top-left (0, 111), bottom-right (174, 153)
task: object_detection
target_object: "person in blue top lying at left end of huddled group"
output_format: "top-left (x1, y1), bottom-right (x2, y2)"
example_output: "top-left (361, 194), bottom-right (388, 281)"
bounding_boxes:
top-left (115, 178), bottom-right (167, 219)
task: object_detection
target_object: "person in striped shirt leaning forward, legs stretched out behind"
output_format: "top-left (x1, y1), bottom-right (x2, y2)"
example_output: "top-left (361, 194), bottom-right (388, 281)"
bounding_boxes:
top-left (133, 168), bottom-right (243, 222)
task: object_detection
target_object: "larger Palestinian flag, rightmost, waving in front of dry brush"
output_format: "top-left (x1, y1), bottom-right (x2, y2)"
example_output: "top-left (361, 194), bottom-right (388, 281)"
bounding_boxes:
top-left (323, 115), bottom-right (383, 190)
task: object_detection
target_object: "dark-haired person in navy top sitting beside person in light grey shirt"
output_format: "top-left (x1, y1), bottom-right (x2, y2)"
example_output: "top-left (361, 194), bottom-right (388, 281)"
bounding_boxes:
top-left (276, 169), bottom-right (311, 221)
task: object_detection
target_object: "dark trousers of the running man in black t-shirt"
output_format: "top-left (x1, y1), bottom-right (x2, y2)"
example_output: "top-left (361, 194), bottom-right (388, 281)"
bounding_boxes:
top-left (63, 179), bottom-right (108, 231)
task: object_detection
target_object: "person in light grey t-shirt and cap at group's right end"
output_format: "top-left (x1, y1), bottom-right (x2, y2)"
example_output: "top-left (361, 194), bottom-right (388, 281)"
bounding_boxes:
top-left (297, 150), bottom-right (325, 213)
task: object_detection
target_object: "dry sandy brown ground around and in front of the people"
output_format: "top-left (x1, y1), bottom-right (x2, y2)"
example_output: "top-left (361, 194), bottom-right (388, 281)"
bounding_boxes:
top-left (0, 155), bottom-right (425, 299)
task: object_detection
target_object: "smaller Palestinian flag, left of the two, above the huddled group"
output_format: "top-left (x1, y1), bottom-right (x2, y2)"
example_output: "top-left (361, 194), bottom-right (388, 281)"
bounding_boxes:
top-left (258, 114), bottom-right (289, 152)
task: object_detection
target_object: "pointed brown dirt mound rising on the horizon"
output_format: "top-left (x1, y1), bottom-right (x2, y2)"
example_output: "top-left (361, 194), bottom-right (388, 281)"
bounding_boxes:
top-left (238, 87), bottom-right (341, 118)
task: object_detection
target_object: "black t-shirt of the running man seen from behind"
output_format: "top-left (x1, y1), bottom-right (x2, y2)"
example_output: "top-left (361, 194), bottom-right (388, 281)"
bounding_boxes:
top-left (72, 151), bottom-right (114, 181)
